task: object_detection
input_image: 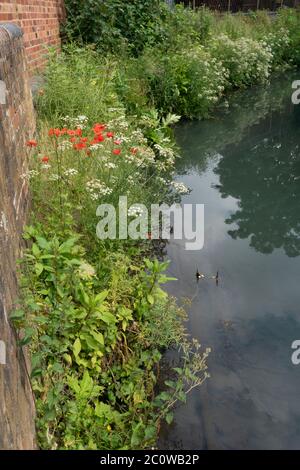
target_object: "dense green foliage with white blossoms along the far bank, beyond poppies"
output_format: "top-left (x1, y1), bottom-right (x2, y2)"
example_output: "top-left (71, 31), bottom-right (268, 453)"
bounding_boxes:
top-left (61, 0), bottom-right (300, 118)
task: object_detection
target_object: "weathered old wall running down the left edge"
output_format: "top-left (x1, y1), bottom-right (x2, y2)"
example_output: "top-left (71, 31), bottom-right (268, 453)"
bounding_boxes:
top-left (0, 24), bottom-right (35, 449)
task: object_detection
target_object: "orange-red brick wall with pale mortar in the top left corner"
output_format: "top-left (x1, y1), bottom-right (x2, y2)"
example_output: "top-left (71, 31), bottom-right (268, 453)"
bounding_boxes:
top-left (0, 0), bottom-right (65, 74)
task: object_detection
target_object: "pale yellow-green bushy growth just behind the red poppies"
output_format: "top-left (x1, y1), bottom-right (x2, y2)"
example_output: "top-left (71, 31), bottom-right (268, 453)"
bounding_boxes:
top-left (36, 44), bottom-right (120, 124)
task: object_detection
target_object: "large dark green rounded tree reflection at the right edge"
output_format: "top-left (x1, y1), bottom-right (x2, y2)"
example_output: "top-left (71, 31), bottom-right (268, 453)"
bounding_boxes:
top-left (215, 105), bottom-right (300, 257)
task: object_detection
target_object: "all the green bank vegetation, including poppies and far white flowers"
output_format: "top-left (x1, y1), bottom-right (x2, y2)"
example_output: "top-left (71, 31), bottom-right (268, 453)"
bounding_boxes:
top-left (12, 0), bottom-right (300, 449)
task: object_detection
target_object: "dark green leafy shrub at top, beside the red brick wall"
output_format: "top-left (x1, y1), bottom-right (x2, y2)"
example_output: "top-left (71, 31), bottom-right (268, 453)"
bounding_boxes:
top-left (64, 0), bottom-right (165, 54)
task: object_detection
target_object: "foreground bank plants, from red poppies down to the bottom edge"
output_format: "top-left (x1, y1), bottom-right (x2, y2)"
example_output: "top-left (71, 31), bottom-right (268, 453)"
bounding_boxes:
top-left (11, 110), bottom-right (209, 449)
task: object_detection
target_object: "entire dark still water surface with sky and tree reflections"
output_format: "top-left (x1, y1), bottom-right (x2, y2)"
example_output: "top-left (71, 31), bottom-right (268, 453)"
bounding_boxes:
top-left (160, 72), bottom-right (300, 449)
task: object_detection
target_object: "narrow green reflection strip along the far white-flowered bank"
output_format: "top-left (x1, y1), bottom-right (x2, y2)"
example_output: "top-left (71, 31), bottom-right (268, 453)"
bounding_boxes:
top-left (176, 75), bottom-right (294, 174)
